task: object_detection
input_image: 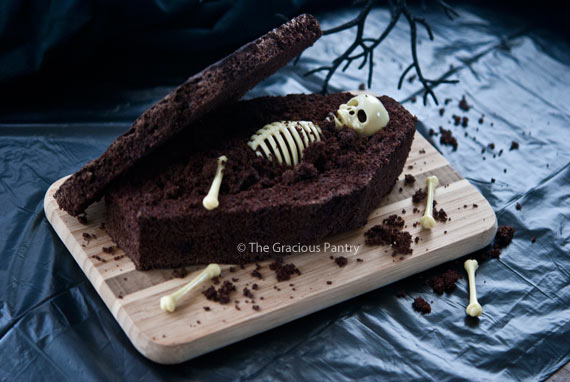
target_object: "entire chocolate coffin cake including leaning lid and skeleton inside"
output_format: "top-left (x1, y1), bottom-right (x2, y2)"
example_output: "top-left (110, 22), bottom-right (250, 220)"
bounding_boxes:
top-left (55, 15), bottom-right (416, 269)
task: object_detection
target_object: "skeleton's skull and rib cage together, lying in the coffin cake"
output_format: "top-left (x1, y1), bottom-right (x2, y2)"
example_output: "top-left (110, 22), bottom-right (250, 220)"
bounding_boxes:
top-left (248, 94), bottom-right (389, 166)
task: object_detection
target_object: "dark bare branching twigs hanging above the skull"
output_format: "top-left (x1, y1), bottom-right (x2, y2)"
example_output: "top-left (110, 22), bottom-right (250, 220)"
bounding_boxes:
top-left (304, 0), bottom-right (459, 104)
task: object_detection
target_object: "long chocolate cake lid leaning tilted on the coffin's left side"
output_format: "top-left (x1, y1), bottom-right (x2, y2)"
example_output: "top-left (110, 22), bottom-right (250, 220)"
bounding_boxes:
top-left (55, 14), bottom-right (321, 216)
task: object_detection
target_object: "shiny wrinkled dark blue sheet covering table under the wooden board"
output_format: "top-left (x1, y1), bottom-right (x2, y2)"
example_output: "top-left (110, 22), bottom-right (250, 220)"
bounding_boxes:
top-left (0, 1), bottom-right (570, 381)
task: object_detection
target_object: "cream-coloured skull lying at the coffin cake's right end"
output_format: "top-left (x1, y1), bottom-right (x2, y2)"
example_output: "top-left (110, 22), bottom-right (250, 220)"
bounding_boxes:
top-left (335, 94), bottom-right (390, 137)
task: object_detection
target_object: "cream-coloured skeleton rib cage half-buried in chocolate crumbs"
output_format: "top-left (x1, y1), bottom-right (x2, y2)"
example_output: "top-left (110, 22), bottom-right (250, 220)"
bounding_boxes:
top-left (247, 121), bottom-right (322, 166)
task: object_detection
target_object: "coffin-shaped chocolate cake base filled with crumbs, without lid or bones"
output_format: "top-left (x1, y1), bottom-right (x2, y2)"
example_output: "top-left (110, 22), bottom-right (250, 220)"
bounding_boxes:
top-left (106, 93), bottom-right (416, 269)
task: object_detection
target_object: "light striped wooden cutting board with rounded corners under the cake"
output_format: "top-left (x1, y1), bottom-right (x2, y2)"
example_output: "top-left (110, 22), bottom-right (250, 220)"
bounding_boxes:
top-left (44, 133), bottom-right (497, 364)
